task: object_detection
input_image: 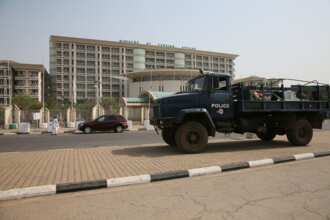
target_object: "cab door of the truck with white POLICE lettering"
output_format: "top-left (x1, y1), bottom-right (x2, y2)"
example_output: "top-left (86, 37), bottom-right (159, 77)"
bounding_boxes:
top-left (208, 76), bottom-right (233, 125)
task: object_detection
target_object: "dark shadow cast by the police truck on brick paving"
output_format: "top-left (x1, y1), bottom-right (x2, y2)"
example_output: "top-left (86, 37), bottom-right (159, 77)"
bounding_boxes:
top-left (112, 140), bottom-right (293, 157)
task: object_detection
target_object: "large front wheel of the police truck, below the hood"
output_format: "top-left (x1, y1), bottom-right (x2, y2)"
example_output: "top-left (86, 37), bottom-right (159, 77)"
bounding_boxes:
top-left (175, 121), bottom-right (208, 153)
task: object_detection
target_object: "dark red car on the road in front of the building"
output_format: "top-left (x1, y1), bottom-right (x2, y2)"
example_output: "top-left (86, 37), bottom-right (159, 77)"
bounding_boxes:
top-left (78, 115), bottom-right (128, 134)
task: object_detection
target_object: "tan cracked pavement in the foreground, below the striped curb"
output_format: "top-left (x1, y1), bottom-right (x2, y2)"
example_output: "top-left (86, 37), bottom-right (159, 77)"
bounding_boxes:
top-left (0, 157), bottom-right (330, 220)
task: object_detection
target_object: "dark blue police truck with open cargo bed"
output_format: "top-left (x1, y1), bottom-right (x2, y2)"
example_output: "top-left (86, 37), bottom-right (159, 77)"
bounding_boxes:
top-left (150, 71), bottom-right (330, 153)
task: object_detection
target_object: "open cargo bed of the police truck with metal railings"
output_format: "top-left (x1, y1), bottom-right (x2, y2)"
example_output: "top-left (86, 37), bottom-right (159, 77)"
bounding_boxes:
top-left (232, 79), bottom-right (330, 114)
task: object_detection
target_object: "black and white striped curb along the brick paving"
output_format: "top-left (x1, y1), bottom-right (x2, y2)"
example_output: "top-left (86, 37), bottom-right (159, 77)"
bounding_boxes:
top-left (0, 150), bottom-right (330, 201)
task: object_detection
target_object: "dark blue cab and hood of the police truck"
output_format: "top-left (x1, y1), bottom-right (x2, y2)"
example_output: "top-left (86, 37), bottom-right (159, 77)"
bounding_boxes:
top-left (150, 72), bottom-right (234, 152)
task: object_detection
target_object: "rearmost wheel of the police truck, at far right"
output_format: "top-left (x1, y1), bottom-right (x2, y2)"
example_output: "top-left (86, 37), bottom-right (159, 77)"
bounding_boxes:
top-left (286, 119), bottom-right (313, 146)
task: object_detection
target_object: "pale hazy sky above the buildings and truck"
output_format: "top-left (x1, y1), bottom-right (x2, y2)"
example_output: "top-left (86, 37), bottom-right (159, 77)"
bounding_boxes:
top-left (0, 0), bottom-right (330, 83)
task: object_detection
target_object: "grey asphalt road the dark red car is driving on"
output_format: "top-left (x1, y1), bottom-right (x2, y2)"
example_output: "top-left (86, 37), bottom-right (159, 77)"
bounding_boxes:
top-left (0, 131), bottom-right (243, 152)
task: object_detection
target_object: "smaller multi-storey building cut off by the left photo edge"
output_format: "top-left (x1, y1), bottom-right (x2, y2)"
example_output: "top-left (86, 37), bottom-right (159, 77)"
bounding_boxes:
top-left (0, 60), bottom-right (47, 105)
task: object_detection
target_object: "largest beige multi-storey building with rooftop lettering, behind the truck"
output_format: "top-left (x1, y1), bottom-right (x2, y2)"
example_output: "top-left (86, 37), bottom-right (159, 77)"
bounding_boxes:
top-left (49, 36), bottom-right (237, 103)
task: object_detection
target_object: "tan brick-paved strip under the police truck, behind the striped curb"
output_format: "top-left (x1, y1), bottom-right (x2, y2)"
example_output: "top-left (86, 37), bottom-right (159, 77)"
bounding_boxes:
top-left (0, 132), bottom-right (330, 190)
